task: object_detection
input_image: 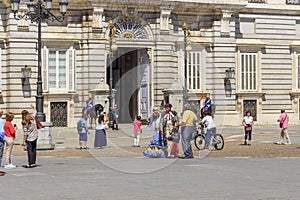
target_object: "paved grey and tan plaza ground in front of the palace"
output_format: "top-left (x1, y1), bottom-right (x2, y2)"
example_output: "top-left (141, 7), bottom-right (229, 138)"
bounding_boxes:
top-left (0, 124), bottom-right (300, 200)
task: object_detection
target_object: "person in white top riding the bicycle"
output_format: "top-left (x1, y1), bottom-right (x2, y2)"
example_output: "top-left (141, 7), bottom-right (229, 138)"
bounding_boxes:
top-left (199, 112), bottom-right (217, 149)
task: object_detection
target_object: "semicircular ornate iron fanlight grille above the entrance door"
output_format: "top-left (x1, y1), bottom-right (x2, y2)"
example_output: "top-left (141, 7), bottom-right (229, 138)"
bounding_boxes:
top-left (114, 17), bottom-right (148, 39)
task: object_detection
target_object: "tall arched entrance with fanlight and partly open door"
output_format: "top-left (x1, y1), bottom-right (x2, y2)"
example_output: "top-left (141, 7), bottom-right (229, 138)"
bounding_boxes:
top-left (106, 15), bottom-right (153, 123)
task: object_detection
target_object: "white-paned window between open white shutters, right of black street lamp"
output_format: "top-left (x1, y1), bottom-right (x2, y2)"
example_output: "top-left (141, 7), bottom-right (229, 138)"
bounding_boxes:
top-left (48, 50), bottom-right (67, 90)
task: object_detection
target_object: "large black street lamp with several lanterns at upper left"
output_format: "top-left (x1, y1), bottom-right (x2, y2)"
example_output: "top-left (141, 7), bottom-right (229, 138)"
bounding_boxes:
top-left (11, 0), bottom-right (68, 122)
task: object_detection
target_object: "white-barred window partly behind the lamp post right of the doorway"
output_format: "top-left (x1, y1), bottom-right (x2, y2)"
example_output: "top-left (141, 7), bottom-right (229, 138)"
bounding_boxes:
top-left (187, 52), bottom-right (201, 91)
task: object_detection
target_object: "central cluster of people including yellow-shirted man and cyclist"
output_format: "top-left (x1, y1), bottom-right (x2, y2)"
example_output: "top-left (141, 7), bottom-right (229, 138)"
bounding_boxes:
top-left (145, 103), bottom-right (216, 159)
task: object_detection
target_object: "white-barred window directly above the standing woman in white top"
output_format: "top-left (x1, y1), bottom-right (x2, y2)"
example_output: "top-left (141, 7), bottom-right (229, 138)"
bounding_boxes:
top-left (240, 53), bottom-right (257, 91)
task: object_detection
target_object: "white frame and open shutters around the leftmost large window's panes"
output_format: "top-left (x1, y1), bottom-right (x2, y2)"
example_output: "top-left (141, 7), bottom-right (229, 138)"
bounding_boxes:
top-left (42, 46), bottom-right (76, 92)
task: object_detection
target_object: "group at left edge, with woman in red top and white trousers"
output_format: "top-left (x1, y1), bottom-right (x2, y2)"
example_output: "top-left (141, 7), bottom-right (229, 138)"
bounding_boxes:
top-left (0, 106), bottom-right (38, 169)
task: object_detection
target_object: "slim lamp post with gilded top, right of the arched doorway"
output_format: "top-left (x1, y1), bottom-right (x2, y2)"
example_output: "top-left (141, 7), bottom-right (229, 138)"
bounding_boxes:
top-left (182, 23), bottom-right (192, 105)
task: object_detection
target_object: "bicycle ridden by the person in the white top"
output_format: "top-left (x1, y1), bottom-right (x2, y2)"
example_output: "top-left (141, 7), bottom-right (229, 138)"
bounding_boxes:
top-left (194, 125), bottom-right (224, 151)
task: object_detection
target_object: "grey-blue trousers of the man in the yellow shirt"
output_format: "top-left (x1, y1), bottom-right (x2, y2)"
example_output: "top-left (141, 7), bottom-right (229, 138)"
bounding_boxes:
top-left (181, 126), bottom-right (194, 157)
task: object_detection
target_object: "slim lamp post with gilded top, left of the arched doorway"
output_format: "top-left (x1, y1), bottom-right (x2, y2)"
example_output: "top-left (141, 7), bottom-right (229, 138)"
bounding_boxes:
top-left (108, 20), bottom-right (118, 128)
